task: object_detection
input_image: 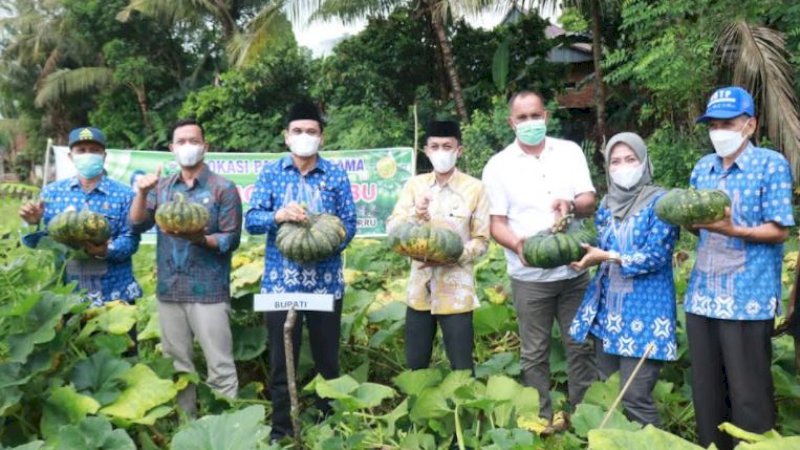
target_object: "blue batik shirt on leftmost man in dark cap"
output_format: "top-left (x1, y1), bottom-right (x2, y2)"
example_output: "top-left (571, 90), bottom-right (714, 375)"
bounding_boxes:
top-left (22, 175), bottom-right (142, 305)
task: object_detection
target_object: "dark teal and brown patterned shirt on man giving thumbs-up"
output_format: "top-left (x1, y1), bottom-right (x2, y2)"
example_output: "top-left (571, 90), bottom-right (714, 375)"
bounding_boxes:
top-left (134, 165), bottom-right (242, 303)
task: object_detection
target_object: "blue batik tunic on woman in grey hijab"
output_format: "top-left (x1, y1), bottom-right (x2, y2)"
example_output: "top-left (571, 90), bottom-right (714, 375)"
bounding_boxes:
top-left (569, 195), bottom-right (679, 361)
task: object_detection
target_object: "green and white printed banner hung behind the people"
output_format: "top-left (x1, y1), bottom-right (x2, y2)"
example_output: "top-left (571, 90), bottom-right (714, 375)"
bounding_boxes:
top-left (54, 147), bottom-right (414, 237)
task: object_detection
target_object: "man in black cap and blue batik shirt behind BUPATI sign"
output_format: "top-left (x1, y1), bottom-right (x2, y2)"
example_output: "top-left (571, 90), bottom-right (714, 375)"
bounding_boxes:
top-left (245, 102), bottom-right (356, 440)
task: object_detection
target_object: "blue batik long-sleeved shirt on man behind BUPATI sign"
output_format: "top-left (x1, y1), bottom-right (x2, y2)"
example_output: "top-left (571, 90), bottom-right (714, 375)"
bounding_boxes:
top-left (245, 156), bottom-right (356, 300)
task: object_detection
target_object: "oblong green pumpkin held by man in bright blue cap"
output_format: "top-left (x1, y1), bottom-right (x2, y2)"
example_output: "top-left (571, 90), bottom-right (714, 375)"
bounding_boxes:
top-left (655, 189), bottom-right (731, 226)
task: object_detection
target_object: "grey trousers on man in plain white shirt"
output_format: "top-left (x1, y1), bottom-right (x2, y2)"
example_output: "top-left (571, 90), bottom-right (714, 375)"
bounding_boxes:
top-left (511, 273), bottom-right (597, 419)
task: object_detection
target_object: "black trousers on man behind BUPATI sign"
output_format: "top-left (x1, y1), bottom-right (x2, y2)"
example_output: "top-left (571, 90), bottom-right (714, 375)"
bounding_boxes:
top-left (266, 300), bottom-right (342, 439)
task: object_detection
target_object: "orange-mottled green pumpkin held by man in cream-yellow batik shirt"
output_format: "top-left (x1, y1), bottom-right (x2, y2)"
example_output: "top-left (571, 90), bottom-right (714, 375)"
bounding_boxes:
top-left (389, 223), bottom-right (464, 264)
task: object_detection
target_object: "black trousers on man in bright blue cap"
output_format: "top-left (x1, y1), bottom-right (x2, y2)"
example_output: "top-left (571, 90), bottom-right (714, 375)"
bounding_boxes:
top-left (686, 313), bottom-right (775, 450)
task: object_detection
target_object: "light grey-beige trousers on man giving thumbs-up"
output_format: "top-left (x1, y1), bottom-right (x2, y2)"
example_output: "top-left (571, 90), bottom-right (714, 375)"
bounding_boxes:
top-left (158, 301), bottom-right (239, 416)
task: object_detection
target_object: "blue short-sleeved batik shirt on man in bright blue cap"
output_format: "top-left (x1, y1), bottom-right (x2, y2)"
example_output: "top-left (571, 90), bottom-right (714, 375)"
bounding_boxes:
top-left (684, 145), bottom-right (794, 320)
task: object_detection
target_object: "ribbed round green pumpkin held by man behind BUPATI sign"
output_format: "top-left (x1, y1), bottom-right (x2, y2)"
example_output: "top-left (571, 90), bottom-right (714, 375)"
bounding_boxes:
top-left (275, 214), bottom-right (347, 264)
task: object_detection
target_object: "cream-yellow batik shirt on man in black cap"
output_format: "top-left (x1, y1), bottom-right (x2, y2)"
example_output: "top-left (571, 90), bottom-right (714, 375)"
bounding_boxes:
top-left (387, 169), bottom-right (489, 314)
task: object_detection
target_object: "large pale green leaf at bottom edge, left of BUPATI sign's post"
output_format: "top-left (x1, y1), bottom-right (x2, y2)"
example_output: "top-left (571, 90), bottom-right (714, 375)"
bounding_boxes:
top-left (170, 405), bottom-right (269, 450)
